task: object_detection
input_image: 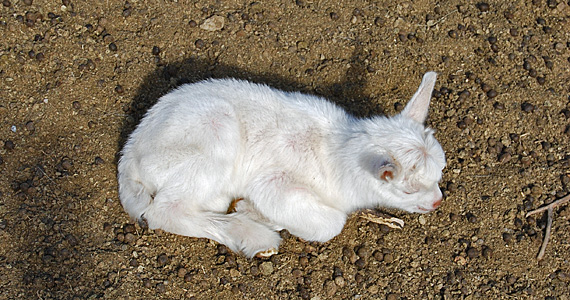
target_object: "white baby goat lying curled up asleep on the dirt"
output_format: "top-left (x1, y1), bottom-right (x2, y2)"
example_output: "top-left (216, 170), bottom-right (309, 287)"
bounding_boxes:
top-left (118, 72), bottom-right (445, 257)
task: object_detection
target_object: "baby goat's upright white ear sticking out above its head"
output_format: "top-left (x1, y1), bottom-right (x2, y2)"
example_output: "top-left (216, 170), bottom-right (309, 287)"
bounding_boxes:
top-left (402, 72), bottom-right (437, 123)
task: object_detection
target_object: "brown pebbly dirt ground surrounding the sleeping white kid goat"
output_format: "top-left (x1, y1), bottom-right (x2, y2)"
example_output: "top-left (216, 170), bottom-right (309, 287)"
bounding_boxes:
top-left (0, 0), bottom-right (570, 300)
